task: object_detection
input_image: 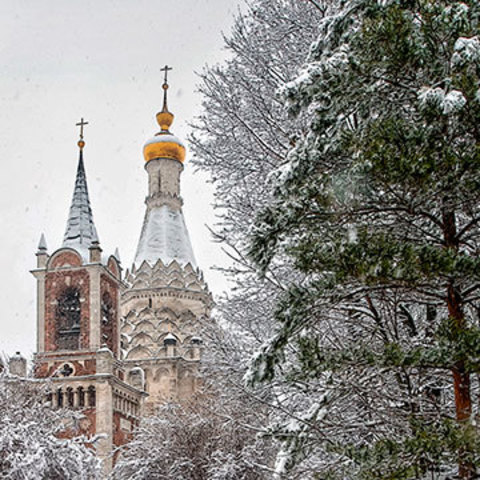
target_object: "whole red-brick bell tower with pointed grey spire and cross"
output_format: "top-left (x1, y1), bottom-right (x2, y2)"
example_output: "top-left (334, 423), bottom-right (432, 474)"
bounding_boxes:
top-left (32, 119), bottom-right (146, 475)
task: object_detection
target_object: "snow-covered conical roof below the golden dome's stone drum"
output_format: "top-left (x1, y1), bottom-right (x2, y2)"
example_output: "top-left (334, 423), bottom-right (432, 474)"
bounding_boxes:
top-left (135, 205), bottom-right (196, 268)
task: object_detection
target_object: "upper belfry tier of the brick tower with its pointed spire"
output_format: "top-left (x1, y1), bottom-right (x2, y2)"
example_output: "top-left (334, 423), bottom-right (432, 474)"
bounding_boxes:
top-left (33, 119), bottom-right (122, 357)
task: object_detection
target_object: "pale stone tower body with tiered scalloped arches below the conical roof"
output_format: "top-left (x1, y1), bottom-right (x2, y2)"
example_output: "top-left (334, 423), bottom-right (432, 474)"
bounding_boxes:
top-left (121, 260), bottom-right (212, 411)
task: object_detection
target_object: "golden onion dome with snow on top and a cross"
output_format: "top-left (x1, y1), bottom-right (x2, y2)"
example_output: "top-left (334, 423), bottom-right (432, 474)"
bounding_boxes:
top-left (143, 70), bottom-right (185, 163)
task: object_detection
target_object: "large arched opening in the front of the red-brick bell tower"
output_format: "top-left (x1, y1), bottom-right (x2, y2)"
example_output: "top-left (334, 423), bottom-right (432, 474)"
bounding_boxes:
top-left (56, 287), bottom-right (81, 350)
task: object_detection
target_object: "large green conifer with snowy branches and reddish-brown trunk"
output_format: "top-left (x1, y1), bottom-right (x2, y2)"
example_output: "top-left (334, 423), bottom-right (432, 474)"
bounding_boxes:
top-left (251, 0), bottom-right (480, 479)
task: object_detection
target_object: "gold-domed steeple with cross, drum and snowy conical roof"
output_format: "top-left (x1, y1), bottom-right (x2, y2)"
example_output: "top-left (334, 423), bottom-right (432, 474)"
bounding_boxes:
top-left (135, 66), bottom-right (196, 267)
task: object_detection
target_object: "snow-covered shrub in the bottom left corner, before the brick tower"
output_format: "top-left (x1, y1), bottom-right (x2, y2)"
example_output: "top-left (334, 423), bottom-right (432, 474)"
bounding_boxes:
top-left (0, 374), bottom-right (99, 480)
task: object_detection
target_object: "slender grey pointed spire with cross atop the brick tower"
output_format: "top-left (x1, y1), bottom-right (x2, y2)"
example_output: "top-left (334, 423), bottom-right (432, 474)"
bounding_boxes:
top-left (63, 118), bottom-right (98, 259)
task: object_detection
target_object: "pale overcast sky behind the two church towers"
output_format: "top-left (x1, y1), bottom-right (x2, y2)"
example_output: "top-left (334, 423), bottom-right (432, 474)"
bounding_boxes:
top-left (0, 0), bottom-right (239, 356)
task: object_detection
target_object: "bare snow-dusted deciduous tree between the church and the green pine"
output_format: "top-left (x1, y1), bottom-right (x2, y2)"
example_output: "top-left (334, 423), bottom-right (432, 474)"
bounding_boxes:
top-left (190, 0), bottom-right (327, 479)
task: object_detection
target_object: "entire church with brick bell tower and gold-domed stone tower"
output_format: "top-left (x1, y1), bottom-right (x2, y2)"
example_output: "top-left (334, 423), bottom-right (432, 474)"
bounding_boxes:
top-left (28, 67), bottom-right (213, 475)
